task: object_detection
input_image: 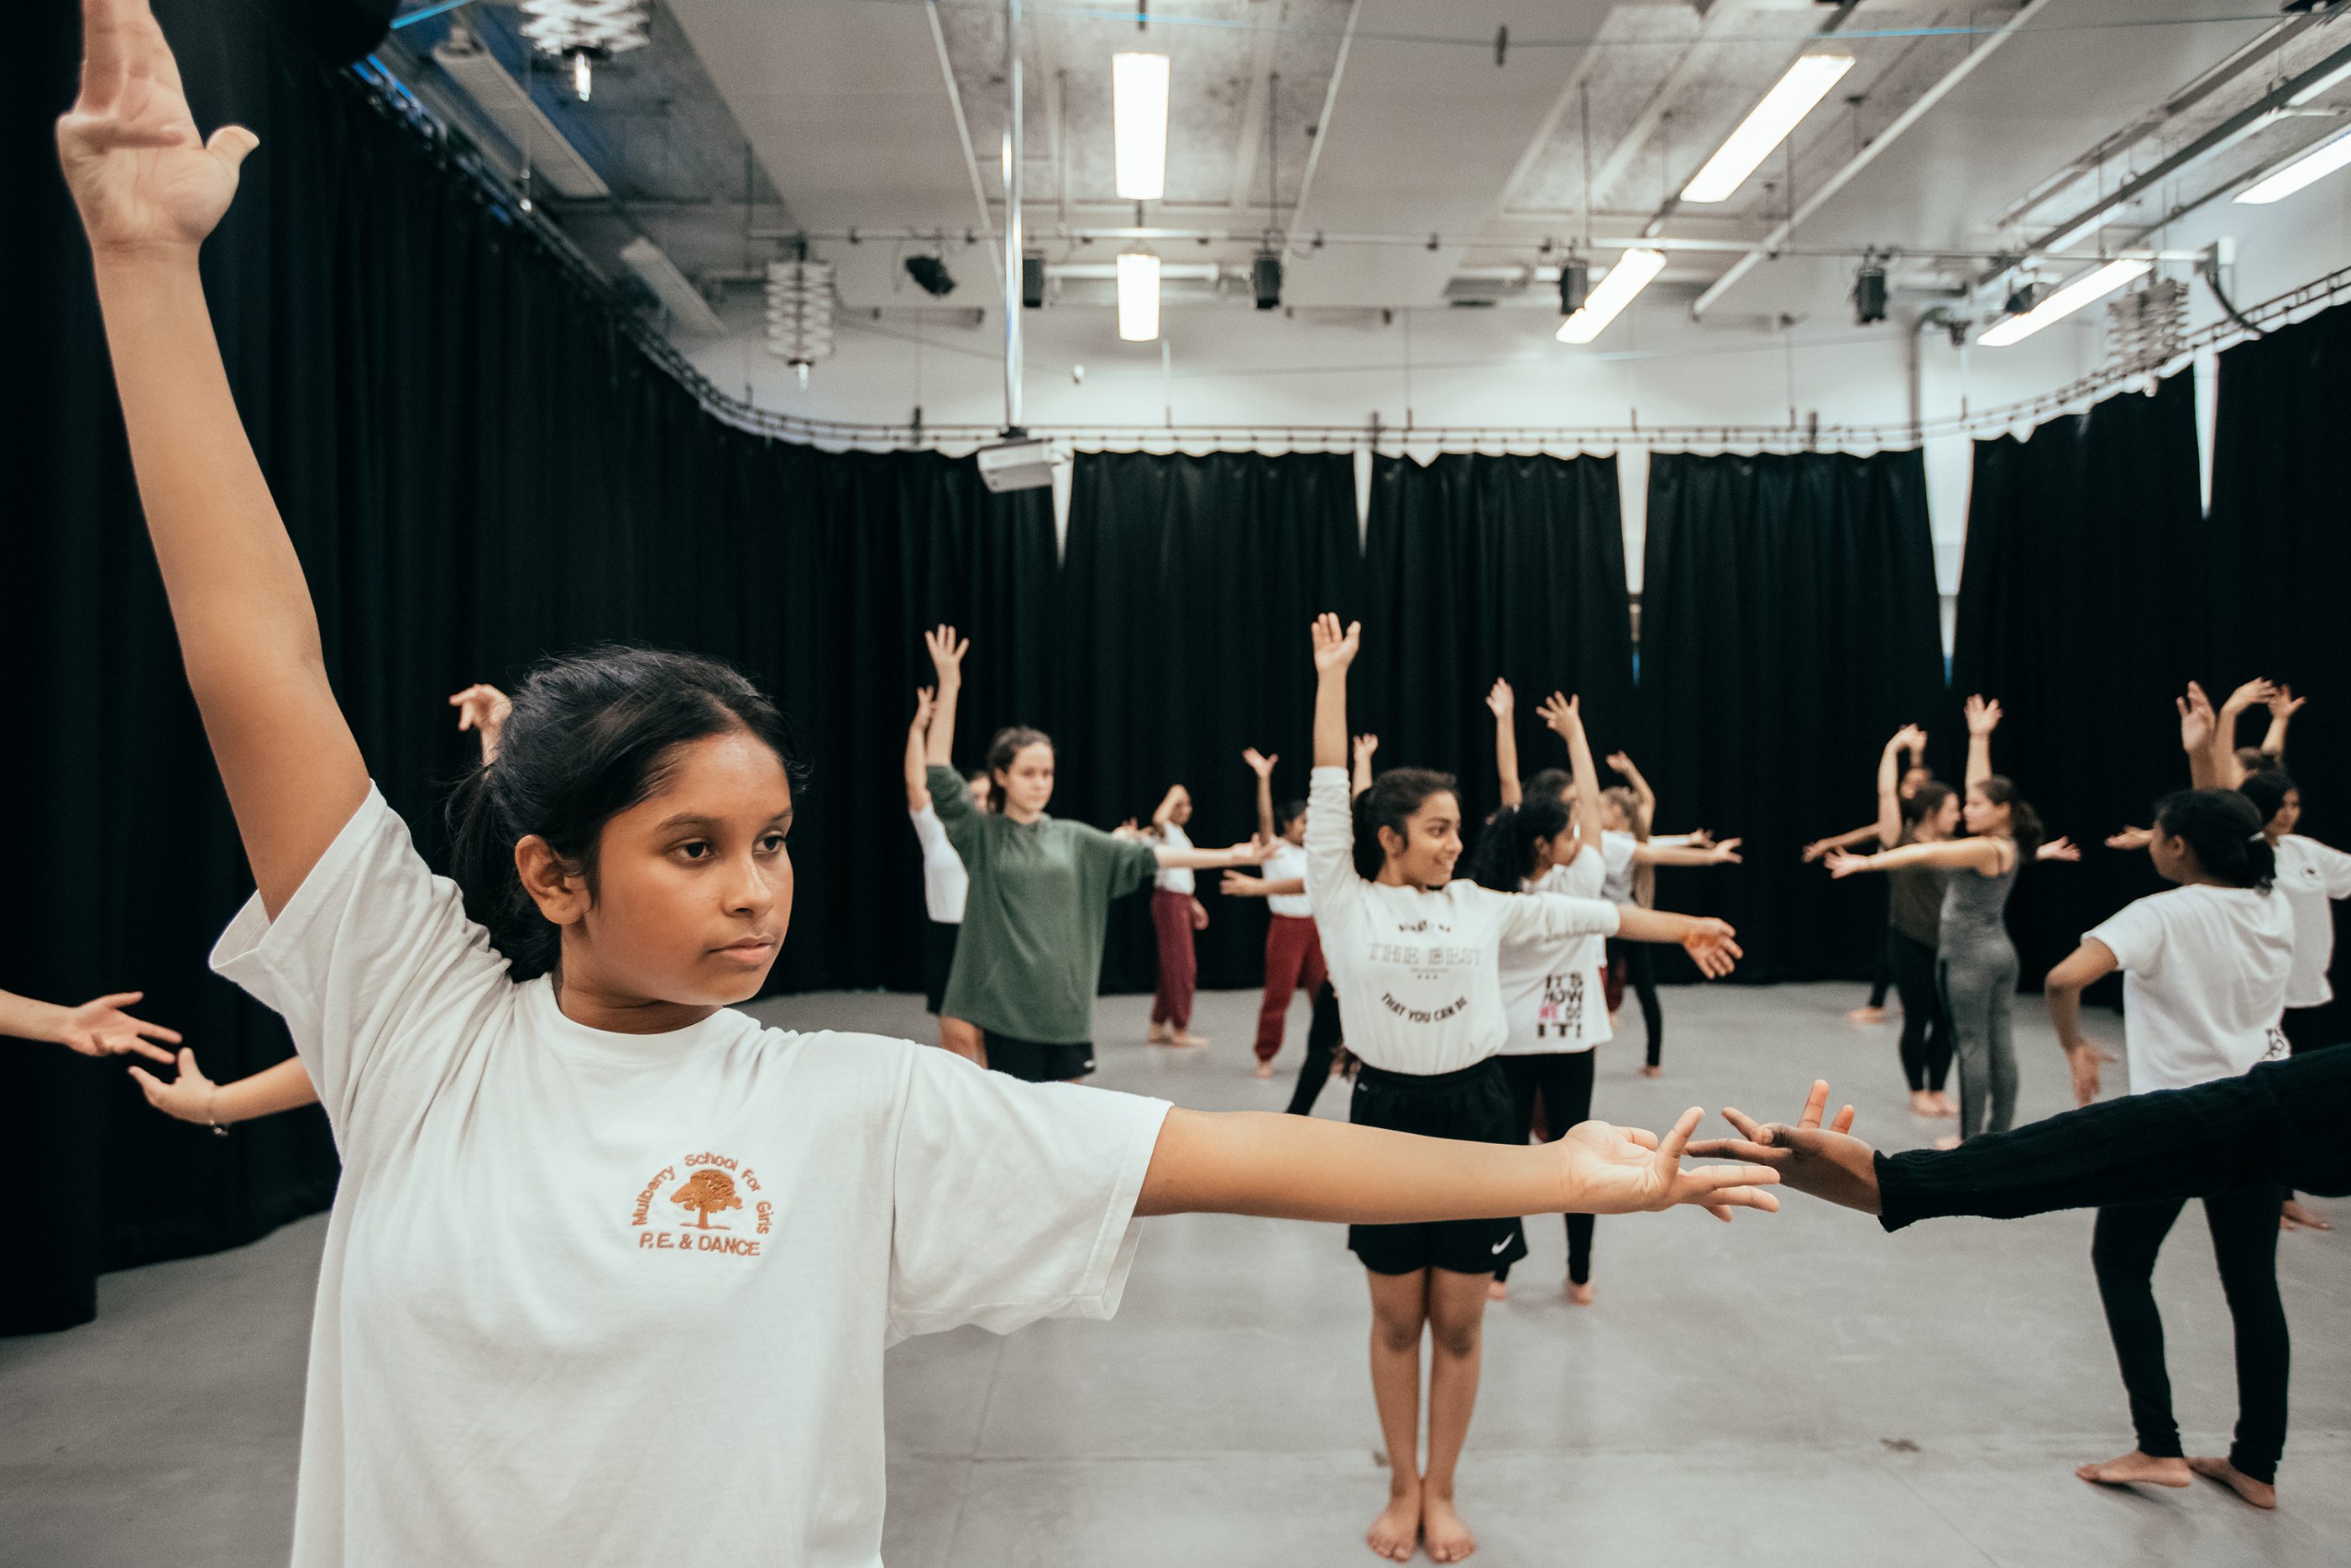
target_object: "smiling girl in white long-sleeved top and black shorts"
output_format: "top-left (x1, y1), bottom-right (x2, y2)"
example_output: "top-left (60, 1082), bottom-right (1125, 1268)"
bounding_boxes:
top-left (1307, 614), bottom-right (1737, 1563)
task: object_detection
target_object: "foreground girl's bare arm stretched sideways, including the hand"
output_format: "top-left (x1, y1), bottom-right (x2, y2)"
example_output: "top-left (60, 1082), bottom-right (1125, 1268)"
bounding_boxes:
top-left (1135, 1107), bottom-right (1780, 1225)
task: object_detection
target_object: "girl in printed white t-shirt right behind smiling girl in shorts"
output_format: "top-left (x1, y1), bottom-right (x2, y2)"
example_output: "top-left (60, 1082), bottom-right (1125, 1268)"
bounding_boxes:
top-left (1469, 691), bottom-right (1731, 1307)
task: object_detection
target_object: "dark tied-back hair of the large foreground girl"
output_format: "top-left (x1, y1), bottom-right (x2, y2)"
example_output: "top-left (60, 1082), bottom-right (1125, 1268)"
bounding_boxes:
top-left (447, 646), bottom-right (804, 980)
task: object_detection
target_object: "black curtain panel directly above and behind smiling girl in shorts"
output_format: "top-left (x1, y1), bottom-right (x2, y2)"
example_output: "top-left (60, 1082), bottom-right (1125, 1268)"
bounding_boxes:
top-left (1349, 454), bottom-right (1631, 827)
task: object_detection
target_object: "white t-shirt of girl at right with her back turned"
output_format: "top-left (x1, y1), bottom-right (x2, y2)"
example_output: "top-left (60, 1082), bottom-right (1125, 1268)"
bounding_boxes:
top-left (2083, 884), bottom-right (2295, 1093)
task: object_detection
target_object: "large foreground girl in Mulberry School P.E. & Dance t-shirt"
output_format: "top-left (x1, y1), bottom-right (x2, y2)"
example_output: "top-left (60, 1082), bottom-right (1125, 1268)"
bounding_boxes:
top-left (56, 18), bottom-right (1772, 1568)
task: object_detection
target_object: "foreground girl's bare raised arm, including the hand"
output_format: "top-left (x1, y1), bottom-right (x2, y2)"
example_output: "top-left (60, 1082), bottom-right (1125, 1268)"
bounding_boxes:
top-left (56, 0), bottom-right (367, 919)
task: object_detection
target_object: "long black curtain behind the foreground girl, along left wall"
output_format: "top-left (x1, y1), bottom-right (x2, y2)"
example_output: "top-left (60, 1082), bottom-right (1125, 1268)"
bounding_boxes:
top-left (0, 0), bottom-right (1058, 1330)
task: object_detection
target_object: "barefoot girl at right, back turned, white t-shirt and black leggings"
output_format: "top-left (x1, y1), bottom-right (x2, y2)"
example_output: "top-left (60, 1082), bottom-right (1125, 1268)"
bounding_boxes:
top-left (2045, 790), bottom-right (2295, 1507)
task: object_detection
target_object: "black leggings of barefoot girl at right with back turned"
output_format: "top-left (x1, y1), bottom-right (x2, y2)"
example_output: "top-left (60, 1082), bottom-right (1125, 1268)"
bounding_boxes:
top-left (2090, 1183), bottom-right (2290, 1481)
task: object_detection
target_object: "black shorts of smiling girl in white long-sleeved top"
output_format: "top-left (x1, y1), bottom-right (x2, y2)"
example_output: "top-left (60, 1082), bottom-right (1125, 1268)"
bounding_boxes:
top-left (1347, 1055), bottom-right (1526, 1274)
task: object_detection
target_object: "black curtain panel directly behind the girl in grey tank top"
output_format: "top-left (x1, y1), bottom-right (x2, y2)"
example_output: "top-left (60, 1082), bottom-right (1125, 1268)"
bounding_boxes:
top-left (1634, 452), bottom-right (1956, 980)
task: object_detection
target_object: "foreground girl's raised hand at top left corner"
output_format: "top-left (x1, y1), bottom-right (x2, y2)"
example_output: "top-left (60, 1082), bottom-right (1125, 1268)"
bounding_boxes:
top-left (56, 0), bottom-right (261, 256)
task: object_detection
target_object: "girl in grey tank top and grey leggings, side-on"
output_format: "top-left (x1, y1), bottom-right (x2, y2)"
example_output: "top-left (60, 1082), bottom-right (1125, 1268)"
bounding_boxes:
top-left (1829, 696), bottom-right (2040, 1140)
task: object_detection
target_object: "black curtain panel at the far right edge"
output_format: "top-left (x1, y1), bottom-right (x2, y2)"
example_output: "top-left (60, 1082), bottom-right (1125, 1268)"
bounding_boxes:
top-left (2207, 306), bottom-right (2351, 1039)
